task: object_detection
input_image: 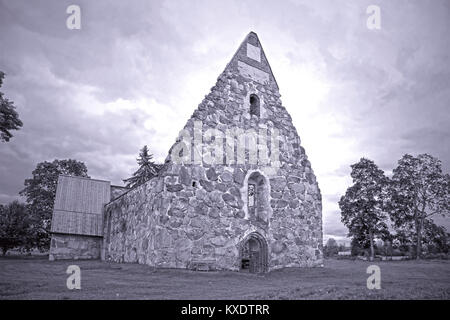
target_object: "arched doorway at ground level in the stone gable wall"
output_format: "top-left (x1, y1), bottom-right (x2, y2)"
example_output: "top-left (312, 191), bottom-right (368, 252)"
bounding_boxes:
top-left (239, 232), bottom-right (268, 273)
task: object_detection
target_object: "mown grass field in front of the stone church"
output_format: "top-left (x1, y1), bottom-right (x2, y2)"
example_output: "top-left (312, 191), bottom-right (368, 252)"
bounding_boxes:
top-left (0, 257), bottom-right (450, 300)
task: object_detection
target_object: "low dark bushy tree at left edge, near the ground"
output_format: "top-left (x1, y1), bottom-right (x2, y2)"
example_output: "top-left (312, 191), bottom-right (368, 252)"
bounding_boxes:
top-left (0, 200), bottom-right (33, 255)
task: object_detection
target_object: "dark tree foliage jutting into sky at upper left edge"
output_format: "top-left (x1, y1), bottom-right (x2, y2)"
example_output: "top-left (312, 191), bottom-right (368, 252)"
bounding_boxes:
top-left (0, 71), bottom-right (23, 142)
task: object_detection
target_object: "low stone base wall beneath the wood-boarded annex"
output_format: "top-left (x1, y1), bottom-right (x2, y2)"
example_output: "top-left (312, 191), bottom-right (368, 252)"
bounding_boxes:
top-left (49, 233), bottom-right (103, 260)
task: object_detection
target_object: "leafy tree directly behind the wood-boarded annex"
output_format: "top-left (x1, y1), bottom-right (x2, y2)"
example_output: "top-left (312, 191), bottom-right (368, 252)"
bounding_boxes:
top-left (20, 159), bottom-right (89, 249)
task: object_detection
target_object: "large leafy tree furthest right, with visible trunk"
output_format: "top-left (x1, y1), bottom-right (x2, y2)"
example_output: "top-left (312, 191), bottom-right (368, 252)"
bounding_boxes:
top-left (388, 154), bottom-right (450, 259)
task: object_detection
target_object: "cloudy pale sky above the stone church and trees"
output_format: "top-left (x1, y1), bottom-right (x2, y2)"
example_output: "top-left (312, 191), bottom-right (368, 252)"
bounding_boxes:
top-left (0, 0), bottom-right (450, 240)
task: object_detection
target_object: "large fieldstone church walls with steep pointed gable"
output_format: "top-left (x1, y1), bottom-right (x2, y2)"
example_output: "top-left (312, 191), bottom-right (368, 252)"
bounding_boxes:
top-left (103, 33), bottom-right (322, 270)
